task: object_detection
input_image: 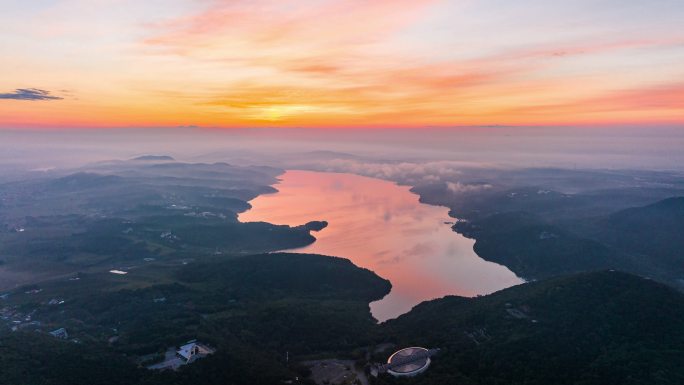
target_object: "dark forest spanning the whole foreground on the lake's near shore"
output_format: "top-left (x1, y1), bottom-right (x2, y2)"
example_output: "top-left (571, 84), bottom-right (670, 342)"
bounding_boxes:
top-left (0, 268), bottom-right (684, 385)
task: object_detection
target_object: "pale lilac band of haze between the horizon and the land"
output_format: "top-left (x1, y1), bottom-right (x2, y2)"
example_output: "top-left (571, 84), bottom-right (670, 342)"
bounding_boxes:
top-left (0, 127), bottom-right (684, 176)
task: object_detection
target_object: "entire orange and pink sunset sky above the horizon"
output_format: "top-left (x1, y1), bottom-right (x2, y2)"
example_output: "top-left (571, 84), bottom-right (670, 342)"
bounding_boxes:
top-left (0, 0), bottom-right (684, 129)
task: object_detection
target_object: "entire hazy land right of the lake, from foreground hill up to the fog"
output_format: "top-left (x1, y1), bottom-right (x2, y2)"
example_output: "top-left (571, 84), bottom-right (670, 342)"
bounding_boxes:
top-left (413, 169), bottom-right (684, 289)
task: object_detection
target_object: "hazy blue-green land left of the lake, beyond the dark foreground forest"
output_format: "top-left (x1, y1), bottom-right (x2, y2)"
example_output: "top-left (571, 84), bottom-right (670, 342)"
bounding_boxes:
top-left (0, 157), bottom-right (316, 289)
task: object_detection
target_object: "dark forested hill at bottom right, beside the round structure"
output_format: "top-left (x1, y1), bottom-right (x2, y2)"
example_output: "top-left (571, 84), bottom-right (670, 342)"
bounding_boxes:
top-left (380, 271), bottom-right (684, 385)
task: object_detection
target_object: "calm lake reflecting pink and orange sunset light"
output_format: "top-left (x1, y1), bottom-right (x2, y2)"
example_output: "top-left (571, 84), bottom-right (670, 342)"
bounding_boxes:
top-left (240, 171), bottom-right (523, 321)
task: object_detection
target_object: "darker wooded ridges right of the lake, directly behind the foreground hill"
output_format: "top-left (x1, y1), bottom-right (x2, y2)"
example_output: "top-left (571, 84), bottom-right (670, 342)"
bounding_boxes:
top-left (454, 198), bottom-right (684, 287)
